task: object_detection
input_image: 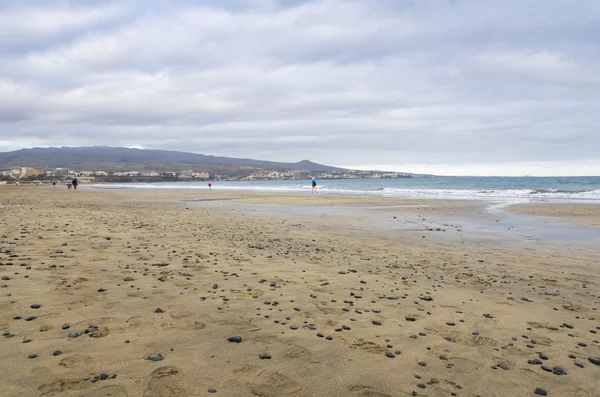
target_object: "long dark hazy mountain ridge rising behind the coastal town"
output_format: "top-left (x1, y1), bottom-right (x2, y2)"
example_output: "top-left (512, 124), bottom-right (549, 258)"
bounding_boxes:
top-left (0, 146), bottom-right (343, 173)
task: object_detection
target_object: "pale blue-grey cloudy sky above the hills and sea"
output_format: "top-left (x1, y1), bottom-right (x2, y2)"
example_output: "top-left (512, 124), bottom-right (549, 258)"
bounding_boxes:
top-left (0, 0), bottom-right (600, 175)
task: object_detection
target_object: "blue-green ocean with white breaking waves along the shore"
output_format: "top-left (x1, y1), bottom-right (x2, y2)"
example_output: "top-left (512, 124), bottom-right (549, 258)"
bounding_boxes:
top-left (94, 177), bottom-right (600, 204)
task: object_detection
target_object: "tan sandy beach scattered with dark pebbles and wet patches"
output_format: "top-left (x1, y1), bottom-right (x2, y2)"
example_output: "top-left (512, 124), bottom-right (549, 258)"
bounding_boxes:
top-left (0, 186), bottom-right (600, 397)
